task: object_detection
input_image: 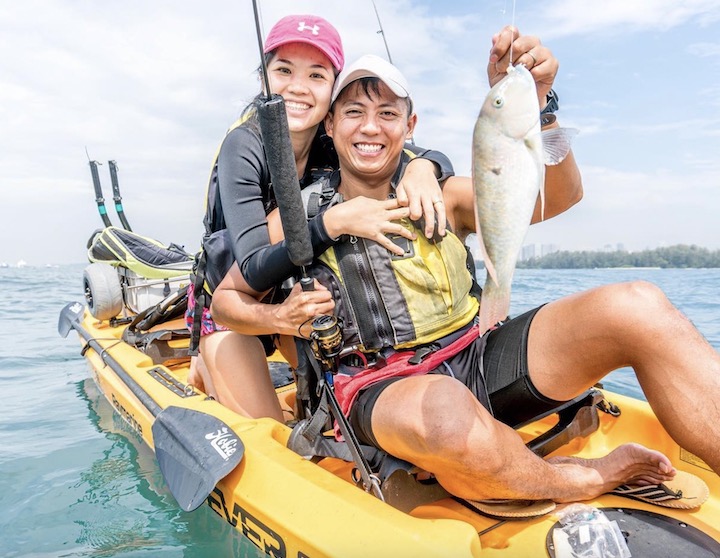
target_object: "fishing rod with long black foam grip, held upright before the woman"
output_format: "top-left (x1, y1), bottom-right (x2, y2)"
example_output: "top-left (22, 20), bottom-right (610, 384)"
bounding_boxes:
top-left (248, 0), bottom-right (383, 500)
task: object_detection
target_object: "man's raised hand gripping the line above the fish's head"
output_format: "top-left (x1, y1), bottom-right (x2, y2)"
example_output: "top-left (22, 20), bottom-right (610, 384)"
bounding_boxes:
top-left (487, 25), bottom-right (560, 109)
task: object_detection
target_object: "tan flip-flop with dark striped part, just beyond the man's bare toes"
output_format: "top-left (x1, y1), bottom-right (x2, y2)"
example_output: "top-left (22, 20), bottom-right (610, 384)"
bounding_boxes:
top-left (609, 471), bottom-right (710, 510)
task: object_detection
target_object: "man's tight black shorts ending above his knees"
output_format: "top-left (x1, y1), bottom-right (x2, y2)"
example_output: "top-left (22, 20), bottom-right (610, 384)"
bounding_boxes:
top-left (350, 308), bottom-right (564, 447)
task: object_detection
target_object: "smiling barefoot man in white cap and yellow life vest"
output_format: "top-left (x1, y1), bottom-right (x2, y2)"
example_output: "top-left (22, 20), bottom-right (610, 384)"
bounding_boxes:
top-left (213, 29), bottom-right (720, 508)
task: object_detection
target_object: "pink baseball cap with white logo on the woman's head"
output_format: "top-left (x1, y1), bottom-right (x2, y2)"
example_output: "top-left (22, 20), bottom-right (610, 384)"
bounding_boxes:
top-left (265, 15), bottom-right (345, 72)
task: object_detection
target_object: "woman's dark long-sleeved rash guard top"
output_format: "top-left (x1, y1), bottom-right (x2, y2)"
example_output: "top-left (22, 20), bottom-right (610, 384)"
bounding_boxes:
top-left (211, 117), bottom-right (453, 292)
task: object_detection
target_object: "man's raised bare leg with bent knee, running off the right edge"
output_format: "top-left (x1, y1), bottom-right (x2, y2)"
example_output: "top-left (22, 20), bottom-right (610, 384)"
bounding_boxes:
top-left (528, 281), bottom-right (720, 473)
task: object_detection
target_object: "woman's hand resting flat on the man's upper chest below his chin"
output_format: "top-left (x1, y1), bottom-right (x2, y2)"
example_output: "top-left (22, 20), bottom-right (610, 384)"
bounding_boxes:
top-left (323, 196), bottom-right (415, 256)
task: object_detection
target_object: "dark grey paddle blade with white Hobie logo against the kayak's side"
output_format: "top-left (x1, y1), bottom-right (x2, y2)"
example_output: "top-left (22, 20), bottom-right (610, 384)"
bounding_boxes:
top-left (152, 407), bottom-right (245, 511)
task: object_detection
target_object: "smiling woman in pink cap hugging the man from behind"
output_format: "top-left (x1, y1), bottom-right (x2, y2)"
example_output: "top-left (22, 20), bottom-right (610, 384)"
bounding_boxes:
top-left (186, 15), bottom-right (452, 420)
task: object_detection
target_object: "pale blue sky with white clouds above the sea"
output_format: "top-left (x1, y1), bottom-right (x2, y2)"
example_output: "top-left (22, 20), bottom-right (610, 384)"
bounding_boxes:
top-left (0, 0), bottom-right (720, 265)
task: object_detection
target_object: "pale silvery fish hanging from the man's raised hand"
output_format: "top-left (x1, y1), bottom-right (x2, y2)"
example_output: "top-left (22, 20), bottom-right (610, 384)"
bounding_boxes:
top-left (472, 65), bottom-right (577, 334)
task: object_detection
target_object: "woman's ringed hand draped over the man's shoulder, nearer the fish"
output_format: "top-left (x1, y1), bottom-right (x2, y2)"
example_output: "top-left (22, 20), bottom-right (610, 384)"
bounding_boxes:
top-left (395, 157), bottom-right (447, 238)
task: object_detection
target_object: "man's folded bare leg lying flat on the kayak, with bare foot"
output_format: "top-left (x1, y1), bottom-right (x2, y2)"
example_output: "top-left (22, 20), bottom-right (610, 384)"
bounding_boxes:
top-left (372, 375), bottom-right (674, 502)
